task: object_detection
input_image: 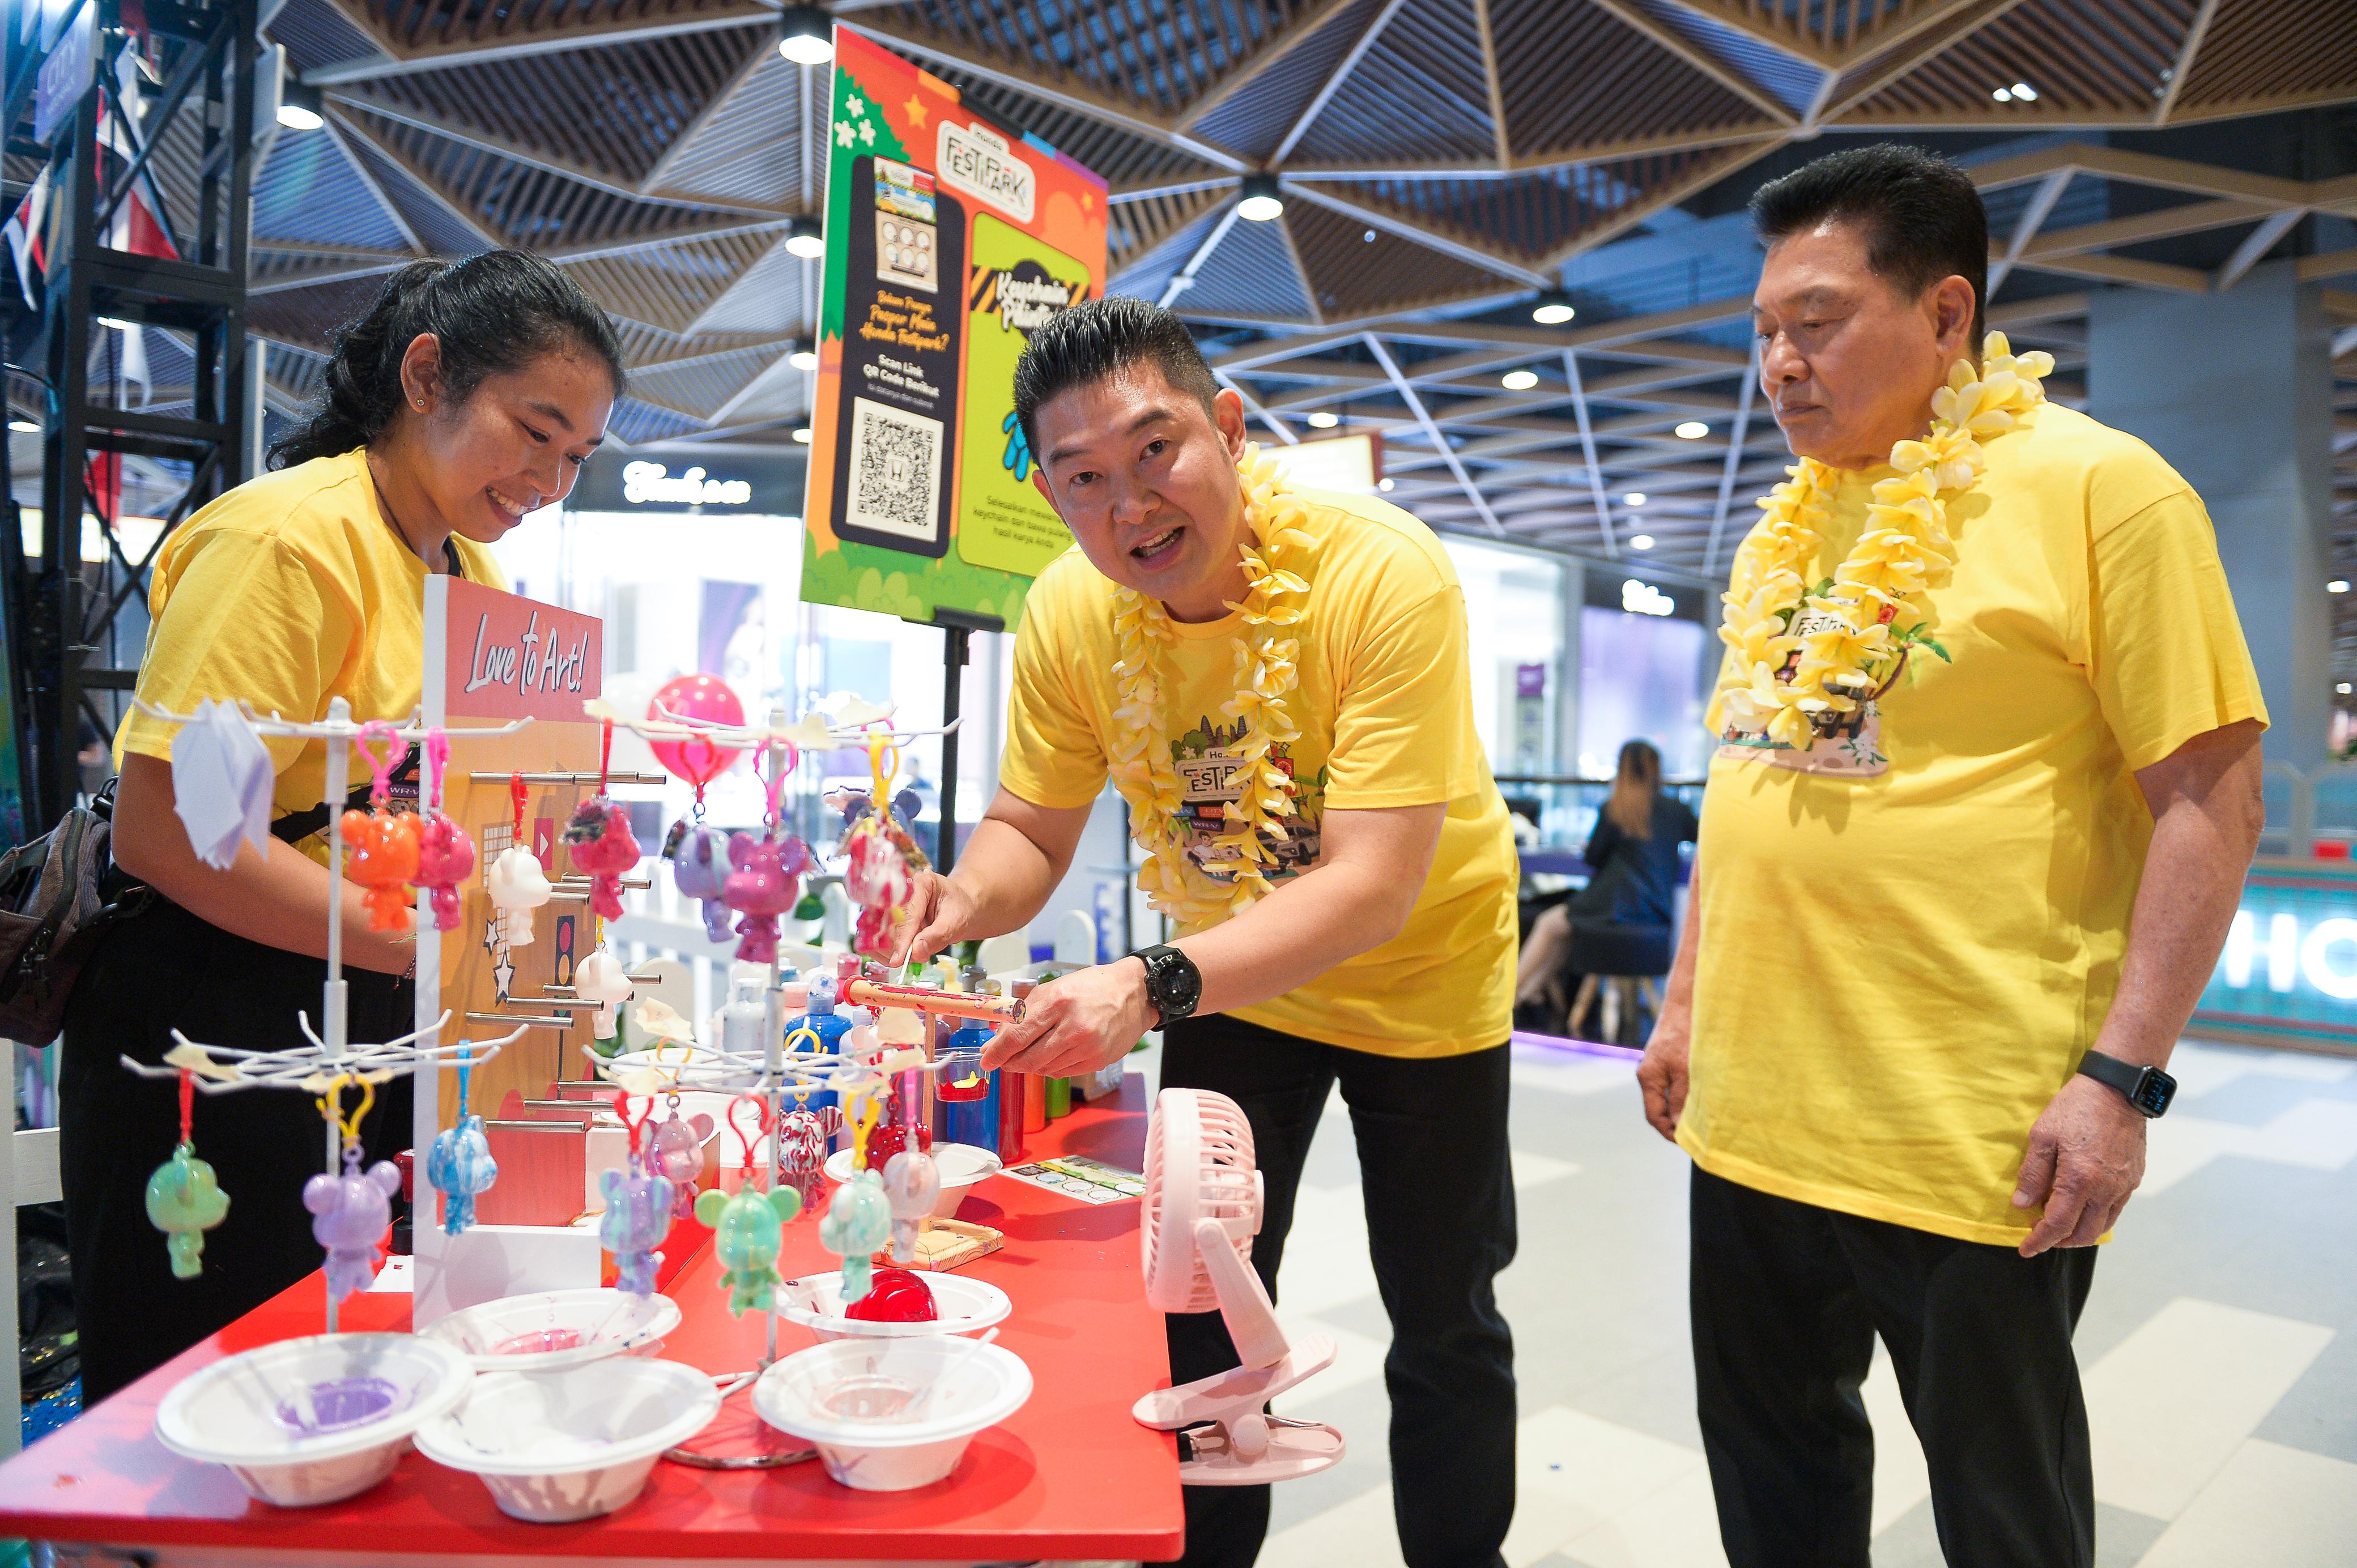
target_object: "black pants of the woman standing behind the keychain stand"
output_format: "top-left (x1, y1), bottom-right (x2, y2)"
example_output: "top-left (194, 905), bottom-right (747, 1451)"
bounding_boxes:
top-left (57, 898), bottom-right (417, 1403)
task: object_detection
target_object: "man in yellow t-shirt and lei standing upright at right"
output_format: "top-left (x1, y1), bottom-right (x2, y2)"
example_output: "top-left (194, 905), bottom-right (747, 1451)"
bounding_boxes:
top-left (1638, 146), bottom-right (2265, 1568)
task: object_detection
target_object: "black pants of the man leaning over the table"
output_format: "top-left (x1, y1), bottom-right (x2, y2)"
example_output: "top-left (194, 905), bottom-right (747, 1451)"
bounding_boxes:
top-left (1162, 1016), bottom-right (1516, 1568)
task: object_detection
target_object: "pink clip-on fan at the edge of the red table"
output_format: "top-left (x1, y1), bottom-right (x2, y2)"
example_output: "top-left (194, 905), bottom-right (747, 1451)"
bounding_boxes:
top-left (1131, 1089), bottom-right (1343, 1485)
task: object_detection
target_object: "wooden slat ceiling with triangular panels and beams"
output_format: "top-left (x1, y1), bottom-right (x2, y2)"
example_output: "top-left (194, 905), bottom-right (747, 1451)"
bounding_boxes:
top-left (229, 0), bottom-right (2357, 613)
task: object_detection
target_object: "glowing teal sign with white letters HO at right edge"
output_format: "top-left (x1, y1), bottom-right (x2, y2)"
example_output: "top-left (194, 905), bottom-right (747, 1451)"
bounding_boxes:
top-left (2190, 860), bottom-right (2357, 1045)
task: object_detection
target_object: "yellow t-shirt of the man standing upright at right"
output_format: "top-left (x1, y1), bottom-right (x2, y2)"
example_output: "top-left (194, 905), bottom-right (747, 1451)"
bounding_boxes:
top-left (1678, 403), bottom-right (2267, 1245)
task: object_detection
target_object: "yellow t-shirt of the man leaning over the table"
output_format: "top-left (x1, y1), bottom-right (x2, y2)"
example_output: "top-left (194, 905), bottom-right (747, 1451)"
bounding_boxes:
top-left (999, 491), bottom-right (1516, 1056)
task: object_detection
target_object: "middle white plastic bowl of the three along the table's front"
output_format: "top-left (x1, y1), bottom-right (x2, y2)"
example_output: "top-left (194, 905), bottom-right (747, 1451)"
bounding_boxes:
top-left (417, 1356), bottom-right (721, 1523)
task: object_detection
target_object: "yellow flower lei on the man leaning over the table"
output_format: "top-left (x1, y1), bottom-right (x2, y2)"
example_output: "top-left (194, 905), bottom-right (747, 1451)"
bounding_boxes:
top-left (1108, 446), bottom-right (1315, 931)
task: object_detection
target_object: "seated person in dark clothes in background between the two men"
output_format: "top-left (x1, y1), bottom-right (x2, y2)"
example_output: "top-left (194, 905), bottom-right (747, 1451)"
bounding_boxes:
top-left (1513, 740), bottom-right (1695, 1033)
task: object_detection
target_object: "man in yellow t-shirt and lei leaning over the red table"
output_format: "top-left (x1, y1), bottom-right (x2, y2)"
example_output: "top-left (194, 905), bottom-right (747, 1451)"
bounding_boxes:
top-left (891, 300), bottom-right (1516, 1568)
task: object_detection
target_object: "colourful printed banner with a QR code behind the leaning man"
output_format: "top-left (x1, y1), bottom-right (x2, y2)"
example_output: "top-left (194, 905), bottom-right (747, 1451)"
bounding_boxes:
top-left (801, 28), bottom-right (1108, 627)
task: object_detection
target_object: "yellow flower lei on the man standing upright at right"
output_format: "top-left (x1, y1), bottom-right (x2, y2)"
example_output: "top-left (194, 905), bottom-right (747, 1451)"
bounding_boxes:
top-left (1718, 333), bottom-right (2056, 750)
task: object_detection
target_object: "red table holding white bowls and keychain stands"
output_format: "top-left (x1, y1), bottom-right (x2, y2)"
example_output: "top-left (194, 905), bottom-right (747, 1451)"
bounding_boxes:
top-left (0, 1077), bottom-right (1181, 1568)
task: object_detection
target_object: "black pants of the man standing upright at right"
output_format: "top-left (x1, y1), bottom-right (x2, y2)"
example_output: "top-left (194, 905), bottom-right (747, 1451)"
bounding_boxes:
top-left (1692, 1170), bottom-right (2095, 1568)
